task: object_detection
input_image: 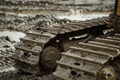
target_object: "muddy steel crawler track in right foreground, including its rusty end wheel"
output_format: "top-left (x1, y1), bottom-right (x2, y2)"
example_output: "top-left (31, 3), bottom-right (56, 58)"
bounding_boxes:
top-left (54, 33), bottom-right (120, 80)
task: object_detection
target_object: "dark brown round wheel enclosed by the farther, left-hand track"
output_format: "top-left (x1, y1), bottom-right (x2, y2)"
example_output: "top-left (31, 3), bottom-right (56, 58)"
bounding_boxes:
top-left (41, 46), bottom-right (61, 69)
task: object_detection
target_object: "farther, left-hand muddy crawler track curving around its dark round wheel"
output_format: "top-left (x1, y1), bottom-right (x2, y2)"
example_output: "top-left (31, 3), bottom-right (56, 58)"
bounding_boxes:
top-left (13, 17), bottom-right (108, 74)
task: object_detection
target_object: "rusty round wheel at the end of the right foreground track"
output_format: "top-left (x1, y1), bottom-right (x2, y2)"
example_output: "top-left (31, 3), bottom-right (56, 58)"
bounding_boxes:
top-left (98, 66), bottom-right (116, 80)
